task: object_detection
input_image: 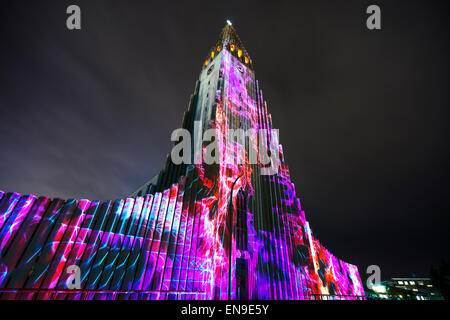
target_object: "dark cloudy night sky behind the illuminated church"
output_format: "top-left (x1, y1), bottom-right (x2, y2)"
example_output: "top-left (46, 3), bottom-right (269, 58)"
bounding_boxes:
top-left (0, 0), bottom-right (450, 279)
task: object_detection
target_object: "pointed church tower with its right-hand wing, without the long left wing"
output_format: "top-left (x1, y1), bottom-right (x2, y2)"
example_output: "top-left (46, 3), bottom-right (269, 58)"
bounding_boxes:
top-left (129, 21), bottom-right (363, 299)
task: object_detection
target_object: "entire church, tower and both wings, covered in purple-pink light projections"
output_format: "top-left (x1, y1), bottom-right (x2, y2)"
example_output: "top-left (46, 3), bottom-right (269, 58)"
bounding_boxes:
top-left (0, 24), bottom-right (364, 300)
